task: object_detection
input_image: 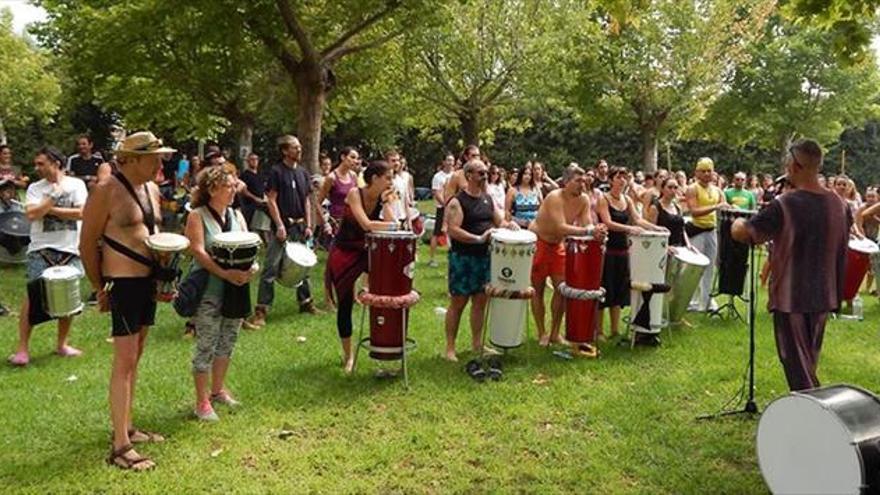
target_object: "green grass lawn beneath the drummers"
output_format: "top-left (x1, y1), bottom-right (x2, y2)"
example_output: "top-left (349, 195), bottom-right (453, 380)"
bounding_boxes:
top-left (0, 242), bottom-right (880, 494)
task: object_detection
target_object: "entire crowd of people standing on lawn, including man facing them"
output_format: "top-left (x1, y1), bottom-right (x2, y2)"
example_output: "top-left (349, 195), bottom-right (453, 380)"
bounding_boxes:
top-left (0, 132), bottom-right (868, 470)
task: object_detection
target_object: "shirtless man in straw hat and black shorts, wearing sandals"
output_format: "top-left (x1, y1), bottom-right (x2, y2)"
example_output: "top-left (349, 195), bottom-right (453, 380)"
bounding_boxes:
top-left (80, 132), bottom-right (175, 471)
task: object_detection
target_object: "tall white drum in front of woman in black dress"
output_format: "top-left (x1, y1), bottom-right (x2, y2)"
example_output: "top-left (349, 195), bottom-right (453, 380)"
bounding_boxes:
top-left (629, 231), bottom-right (669, 333)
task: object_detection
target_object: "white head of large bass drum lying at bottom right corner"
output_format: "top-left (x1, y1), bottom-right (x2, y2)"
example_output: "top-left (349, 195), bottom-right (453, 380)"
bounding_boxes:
top-left (758, 395), bottom-right (862, 494)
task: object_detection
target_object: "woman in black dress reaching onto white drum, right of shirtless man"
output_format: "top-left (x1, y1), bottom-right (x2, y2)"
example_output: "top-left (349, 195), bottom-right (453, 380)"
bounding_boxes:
top-left (599, 167), bottom-right (665, 338)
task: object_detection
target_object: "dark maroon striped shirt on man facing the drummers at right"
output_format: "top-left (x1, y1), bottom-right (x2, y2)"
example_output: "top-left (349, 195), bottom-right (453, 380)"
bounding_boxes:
top-left (748, 190), bottom-right (852, 313)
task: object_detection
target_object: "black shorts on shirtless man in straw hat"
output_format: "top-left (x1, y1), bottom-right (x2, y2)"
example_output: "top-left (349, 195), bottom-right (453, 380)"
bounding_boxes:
top-left (108, 277), bottom-right (156, 337)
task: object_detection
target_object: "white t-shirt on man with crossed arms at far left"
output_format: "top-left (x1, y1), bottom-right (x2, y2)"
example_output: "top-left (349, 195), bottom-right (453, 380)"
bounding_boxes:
top-left (27, 175), bottom-right (89, 256)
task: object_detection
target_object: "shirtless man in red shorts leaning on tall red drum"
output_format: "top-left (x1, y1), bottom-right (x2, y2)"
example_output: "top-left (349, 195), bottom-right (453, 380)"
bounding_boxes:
top-left (530, 165), bottom-right (608, 346)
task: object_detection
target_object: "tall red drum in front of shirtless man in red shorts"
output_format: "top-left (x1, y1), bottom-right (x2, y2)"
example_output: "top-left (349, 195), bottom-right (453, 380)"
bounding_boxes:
top-left (565, 236), bottom-right (605, 344)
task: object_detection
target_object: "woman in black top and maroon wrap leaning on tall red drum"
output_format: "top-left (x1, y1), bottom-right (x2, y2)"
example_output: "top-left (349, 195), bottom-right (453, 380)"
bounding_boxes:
top-left (325, 161), bottom-right (397, 373)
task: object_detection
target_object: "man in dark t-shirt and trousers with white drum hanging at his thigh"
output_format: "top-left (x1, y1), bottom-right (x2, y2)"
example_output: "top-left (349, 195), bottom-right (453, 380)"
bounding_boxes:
top-left (245, 136), bottom-right (318, 328)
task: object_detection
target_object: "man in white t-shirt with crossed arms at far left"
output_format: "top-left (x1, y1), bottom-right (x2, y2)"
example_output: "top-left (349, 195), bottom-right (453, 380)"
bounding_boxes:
top-left (9, 147), bottom-right (88, 366)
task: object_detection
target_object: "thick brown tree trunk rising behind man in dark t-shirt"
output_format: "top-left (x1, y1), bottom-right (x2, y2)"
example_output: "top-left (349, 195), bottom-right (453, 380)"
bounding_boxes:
top-left (296, 67), bottom-right (327, 174)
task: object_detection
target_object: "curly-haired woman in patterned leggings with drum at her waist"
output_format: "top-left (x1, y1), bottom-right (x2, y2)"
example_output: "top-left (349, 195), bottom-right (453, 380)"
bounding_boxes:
top-left (185, 167), bottom-right (256, 421)
